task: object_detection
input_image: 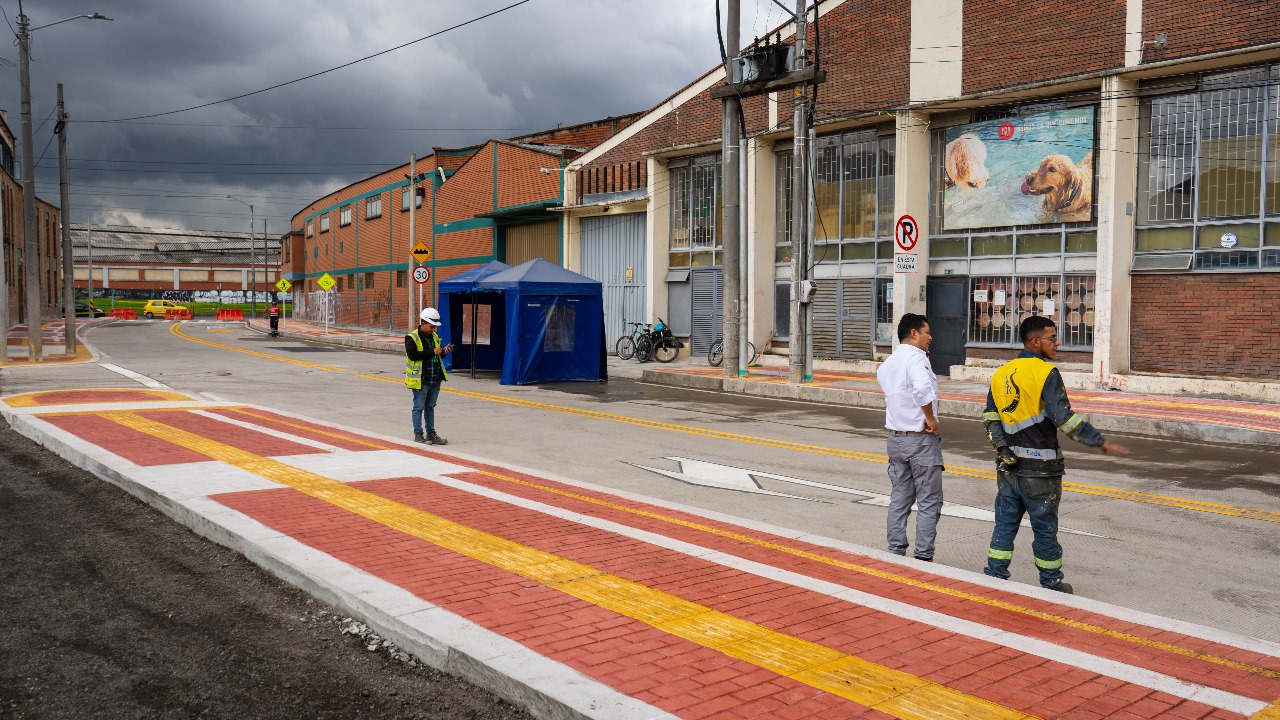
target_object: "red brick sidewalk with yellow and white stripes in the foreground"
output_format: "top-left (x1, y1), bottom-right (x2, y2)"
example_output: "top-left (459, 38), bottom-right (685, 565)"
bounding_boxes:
top-left (0, 389), bottom-right (1280, 720)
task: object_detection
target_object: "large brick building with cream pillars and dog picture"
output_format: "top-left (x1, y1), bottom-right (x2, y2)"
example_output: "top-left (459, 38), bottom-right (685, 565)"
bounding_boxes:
top-left (563, 0), bottom-right (1280, 395)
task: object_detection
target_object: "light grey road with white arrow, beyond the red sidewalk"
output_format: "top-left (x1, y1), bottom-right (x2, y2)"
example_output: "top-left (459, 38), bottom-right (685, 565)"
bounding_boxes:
top-left (0, 322), bottom-right (1280, 716)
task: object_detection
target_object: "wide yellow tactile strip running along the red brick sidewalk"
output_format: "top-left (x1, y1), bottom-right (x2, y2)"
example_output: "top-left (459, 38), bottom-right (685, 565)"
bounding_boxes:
top-left (101, 413), bottom-right (1033, 720)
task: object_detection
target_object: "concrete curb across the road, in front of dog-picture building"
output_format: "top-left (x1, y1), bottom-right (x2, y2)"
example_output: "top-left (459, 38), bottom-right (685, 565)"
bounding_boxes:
top-left (640, 370), bottom-right (1280, 447)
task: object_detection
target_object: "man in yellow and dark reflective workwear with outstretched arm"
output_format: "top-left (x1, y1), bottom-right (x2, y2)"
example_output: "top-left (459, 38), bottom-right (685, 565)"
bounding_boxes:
top-left (982, 315), bottom-right (1129, 593)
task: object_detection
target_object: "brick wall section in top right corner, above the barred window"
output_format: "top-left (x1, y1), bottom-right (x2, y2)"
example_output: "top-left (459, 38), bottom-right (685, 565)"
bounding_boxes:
top-left (1142, 0), bottom-right (1280, 63)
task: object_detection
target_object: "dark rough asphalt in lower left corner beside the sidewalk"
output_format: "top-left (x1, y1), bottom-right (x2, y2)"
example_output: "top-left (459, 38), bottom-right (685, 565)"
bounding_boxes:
top-left (0, 415), bottom-right (529, 720)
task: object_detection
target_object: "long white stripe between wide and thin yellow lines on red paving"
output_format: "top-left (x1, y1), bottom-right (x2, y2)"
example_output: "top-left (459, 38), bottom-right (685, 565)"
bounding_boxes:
top-left (417, 478), bottom-right (1267, 715)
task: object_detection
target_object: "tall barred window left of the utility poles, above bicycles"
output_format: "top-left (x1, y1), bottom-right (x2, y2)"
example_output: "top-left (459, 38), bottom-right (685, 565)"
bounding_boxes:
top-left (668, 152), bottom-right (724, 268)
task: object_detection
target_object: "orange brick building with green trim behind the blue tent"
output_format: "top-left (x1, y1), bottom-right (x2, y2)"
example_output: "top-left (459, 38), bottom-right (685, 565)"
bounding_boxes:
top-left (282, 115), bottom-right (636, 329)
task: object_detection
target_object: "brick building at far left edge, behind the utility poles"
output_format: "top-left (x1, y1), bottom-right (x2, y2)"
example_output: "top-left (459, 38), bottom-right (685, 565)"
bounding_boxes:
top-left (0, 110), bottom-right (61, 325)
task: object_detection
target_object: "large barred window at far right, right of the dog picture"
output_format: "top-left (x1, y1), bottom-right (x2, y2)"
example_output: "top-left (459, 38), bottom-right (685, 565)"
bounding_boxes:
top-left (1135, 65), bottom-right (1280, 270)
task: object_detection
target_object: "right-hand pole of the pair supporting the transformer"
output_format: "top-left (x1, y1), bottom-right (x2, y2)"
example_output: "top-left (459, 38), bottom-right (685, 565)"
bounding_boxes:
top-left (787, 0), bottom-right (813, 384)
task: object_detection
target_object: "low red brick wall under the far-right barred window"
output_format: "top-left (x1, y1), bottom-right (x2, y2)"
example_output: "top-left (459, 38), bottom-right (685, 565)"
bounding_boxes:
top-left (1130, 273), bottom-right (1280, 380)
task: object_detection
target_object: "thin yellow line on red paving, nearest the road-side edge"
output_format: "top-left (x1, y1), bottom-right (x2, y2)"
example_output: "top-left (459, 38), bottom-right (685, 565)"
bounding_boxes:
top-left (475, 470), bottom-right (1280, 679)
